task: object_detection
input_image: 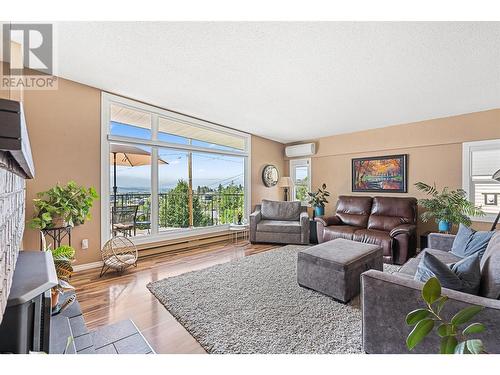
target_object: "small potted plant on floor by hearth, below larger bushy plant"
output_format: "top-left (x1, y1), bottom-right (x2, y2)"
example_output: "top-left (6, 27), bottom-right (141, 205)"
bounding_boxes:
top-left (44, 245), bottom-right (75, 307)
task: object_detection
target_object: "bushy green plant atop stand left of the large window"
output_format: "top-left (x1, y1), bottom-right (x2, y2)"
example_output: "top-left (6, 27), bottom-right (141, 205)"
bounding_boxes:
top-left (30, 181), bottom-right (99, 229)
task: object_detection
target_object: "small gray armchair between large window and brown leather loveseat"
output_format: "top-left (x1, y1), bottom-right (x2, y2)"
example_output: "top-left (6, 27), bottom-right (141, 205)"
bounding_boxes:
top-left (250, 200), bottom-right (309, 245)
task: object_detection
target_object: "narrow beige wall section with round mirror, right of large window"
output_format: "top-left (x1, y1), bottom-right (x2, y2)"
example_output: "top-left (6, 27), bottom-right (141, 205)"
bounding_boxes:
top-left (251, 136), bottom-right (285, 209)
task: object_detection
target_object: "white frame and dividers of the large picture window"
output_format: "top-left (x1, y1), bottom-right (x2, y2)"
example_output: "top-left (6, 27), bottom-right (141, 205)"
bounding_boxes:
top-left (100, 92), bottom-right (252, 246)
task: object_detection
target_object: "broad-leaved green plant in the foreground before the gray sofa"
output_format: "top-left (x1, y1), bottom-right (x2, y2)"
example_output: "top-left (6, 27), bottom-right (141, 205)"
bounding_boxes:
top-left (406, 277), bottom-right (486, 354)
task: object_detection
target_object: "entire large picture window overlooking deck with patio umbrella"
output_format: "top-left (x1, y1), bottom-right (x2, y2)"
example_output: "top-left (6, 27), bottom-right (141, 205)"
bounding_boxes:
top-left (101, 94), bottom-right (250, 243)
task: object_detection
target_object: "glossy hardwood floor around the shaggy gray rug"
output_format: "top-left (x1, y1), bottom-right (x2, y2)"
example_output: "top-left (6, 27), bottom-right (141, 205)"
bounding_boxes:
top-left (72, 243), bottom-right (279, 353)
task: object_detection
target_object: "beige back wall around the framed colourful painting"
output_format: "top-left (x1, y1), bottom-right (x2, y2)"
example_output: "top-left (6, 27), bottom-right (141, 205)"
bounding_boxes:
top-left (292, 109), bottom-right (500, 238)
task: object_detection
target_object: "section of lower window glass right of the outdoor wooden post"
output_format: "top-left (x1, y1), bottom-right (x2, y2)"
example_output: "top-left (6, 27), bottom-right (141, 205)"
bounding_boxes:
top-left (193, 153), bottom-right (245, 227)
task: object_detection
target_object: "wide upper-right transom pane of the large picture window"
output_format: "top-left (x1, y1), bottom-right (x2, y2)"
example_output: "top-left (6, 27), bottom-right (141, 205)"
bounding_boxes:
top-left (158, 117), bottom-right (245, 151)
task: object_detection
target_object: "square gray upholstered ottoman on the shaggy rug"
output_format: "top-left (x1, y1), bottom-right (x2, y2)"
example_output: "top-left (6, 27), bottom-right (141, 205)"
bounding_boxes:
top-left (297, 238), bottom-right (383, 302)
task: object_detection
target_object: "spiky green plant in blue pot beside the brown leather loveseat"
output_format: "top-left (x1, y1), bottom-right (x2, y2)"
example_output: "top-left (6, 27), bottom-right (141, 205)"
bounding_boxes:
top-left (415, 182), bottom-right (485, 233)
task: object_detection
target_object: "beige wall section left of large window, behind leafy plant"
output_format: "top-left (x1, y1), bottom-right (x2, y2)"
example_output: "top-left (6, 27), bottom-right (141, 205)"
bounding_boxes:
top-left (24, 79), bottom-right (101, 264)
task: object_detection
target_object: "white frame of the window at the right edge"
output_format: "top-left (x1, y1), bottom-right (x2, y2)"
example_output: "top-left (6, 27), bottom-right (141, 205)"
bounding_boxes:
top-left (462, 139), bottom-right (500, 223)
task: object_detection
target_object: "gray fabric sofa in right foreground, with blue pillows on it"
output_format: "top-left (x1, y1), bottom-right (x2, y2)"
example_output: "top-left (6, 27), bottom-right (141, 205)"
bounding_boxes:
top-left (361, 231), bottom-right (500, 354)
